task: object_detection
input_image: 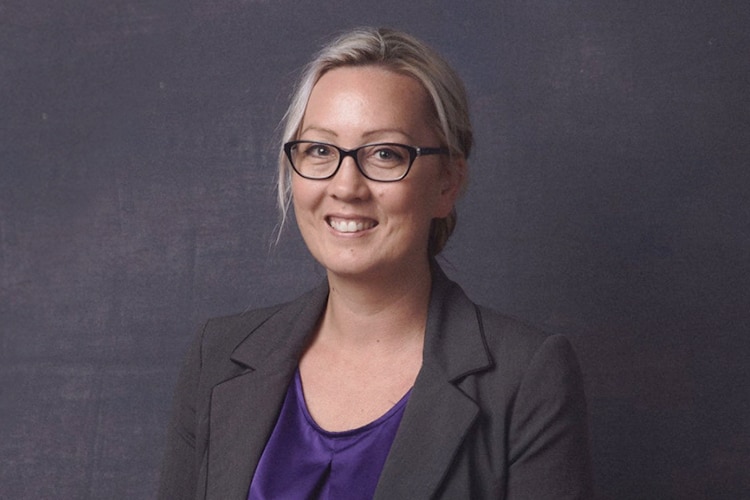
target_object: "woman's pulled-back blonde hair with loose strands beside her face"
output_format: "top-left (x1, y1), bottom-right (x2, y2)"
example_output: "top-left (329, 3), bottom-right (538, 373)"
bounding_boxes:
top-left (278, 28), bottom-right (473, 255)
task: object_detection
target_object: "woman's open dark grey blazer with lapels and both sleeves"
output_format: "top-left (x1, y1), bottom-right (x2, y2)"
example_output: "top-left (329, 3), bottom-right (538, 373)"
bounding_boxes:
top-left (159, 266), bottom-right (591, 500)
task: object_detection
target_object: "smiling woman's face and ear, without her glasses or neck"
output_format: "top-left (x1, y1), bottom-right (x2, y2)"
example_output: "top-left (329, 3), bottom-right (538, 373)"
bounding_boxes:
top-left (292, 66), bottom-right (459, 277)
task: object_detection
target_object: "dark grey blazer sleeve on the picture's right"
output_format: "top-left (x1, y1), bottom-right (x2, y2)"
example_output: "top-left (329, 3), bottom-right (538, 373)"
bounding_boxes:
top-left (507, 335), bottom-right (593, 500)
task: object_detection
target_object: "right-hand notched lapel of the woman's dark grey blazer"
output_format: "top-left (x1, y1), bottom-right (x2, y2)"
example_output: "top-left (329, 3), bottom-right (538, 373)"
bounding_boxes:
top-left (375, 266), bottom-right (492, 499)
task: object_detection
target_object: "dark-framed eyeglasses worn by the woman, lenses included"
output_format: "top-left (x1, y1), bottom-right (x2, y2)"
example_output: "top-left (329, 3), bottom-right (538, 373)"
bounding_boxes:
top-left (284, 141), bottom-right (449, 182)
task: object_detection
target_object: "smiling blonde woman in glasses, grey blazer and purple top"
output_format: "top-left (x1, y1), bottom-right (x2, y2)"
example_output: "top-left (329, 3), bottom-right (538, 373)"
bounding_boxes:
top-left (160, 29), bottom-right (591, 499)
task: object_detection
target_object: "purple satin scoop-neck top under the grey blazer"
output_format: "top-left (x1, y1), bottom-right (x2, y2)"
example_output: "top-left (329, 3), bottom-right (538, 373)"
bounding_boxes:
top-left (248, 370), bottom-right (411, 500)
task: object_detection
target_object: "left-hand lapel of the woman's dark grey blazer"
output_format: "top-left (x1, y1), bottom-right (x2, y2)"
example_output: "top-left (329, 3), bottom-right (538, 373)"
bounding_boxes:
top-left (206, 284), bottom-right (328, 500)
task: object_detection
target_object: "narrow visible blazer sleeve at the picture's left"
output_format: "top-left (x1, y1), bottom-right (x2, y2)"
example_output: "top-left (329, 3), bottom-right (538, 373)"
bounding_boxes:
top-left (157, 328), bottom-right (205, 500)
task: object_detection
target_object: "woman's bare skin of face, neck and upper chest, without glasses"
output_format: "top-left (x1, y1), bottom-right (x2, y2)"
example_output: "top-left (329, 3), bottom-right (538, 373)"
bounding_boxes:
top-left (292, 66), bottom-right (464, 431)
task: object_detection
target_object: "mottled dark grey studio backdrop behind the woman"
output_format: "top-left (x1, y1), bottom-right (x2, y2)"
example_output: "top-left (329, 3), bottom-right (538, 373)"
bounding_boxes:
top-left (0, 0), bottom-right (750, 499)
